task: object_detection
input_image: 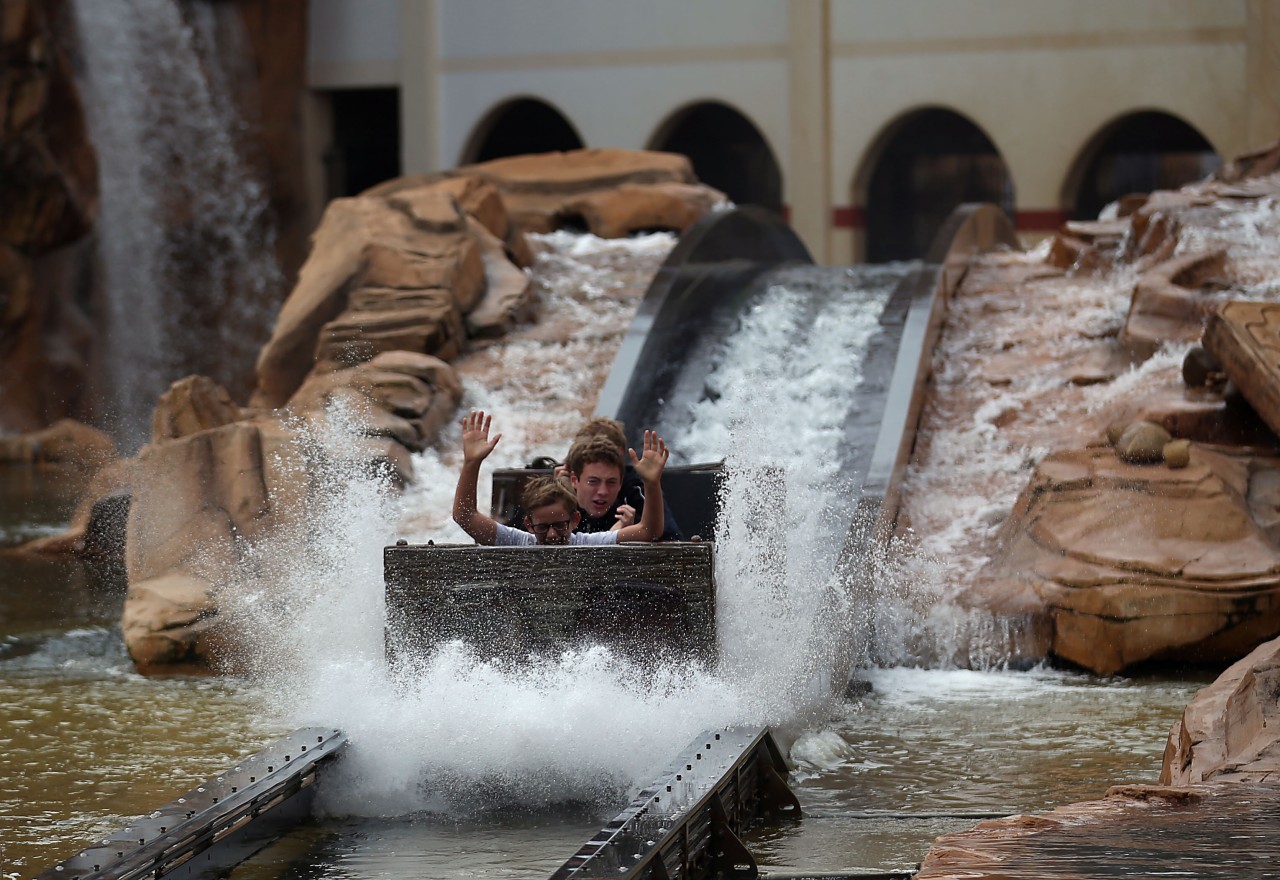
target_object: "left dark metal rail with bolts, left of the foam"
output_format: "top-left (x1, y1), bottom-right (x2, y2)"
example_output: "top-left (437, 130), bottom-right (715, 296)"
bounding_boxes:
top-left (36, 728), bottom-right (347, 880)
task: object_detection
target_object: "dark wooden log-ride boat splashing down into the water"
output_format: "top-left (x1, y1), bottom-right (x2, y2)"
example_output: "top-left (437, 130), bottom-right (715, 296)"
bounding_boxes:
top-left (383, 464), bottom-right (719, 661)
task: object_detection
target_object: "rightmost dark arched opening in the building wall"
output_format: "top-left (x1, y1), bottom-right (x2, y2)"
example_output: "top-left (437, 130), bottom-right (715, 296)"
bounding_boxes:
top-left (1064, 110), bottom-right (1221, 220)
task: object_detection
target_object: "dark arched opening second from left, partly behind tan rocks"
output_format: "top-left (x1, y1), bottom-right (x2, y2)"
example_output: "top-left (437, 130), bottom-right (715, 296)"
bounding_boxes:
top-left (650, 101), bottom-right (782, 214)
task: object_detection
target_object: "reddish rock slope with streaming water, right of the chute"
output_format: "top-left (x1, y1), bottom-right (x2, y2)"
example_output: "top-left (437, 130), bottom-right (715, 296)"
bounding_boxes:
top-left (900, 145), bottom-right (1280, 674)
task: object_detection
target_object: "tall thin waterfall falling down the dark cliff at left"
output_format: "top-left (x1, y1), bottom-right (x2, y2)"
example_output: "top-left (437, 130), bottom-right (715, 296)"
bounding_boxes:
top-left (74, 0), bottom-right (280, 448)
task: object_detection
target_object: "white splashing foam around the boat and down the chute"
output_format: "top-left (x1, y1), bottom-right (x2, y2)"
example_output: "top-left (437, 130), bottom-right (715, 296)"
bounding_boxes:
top-left (220, 239), bottom-right (916, 815)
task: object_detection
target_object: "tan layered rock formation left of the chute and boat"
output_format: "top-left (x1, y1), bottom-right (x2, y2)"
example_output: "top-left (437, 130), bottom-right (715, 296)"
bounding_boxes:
top-left (123, 150), bottom-right (723, 674)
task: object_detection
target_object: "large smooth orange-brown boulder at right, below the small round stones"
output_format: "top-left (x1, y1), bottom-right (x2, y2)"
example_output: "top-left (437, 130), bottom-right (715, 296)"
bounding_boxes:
top-left (964, 444), bottom-right (1280, 675)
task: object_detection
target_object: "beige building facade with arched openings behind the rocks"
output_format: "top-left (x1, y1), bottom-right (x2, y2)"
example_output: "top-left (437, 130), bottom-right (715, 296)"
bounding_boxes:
top-left (308, 0), bottom-right (1280, 263)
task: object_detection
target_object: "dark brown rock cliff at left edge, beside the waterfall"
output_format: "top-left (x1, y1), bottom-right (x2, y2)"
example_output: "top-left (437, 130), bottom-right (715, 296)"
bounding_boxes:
top-left (0, 0), bottom-right (97, 431)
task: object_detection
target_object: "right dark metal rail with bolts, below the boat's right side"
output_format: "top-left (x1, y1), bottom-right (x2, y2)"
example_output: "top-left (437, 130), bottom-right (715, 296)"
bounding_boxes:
top-left (552, 728), bottom-right (800, 880)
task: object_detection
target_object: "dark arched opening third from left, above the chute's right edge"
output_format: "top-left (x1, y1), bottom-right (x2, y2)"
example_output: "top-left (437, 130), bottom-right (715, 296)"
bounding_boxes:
top-left (867, 109), bottom-right (1014, 262)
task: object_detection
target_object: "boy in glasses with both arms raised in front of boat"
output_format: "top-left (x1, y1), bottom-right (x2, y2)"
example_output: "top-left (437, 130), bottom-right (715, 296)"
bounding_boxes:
top-left (453, 409), bottom-right (669, 546)
